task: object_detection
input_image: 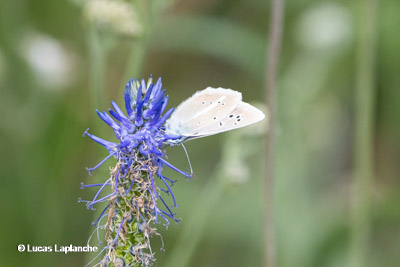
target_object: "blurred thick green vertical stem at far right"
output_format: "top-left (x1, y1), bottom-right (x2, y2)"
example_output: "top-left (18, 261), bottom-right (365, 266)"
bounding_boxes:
top-left (350, 0), bottom-right (378, 267)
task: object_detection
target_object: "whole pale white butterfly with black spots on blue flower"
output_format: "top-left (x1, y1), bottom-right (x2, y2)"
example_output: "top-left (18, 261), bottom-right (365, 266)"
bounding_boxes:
top-left (165, 87), bottom-right (265, 145)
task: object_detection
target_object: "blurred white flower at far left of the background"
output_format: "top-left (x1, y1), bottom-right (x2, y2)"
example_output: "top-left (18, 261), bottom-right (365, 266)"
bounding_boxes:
top-left (20, 33), bottom-right (76, 90)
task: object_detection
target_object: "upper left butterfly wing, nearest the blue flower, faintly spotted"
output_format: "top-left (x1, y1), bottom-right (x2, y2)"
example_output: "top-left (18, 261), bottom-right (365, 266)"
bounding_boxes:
top-left (165, 87), bottom-right (242, 137)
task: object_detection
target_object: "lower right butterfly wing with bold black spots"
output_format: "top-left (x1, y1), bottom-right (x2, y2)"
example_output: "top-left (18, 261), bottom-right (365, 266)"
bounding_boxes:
top-left (191, 101), bottom-right (265, 137)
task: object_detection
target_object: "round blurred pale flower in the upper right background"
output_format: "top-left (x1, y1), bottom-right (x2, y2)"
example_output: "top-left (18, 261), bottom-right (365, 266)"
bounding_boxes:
top-left (296, 2), bottom-right (353, 53)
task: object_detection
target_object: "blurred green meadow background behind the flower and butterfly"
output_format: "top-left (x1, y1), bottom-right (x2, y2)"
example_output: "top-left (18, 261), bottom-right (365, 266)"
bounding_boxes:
top-left (0, 0), bottom-right (400, 267)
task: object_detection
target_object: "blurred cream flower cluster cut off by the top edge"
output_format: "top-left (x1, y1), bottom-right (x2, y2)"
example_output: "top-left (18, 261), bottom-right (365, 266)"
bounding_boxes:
top-left (83, 0), bottom-right (142, 35)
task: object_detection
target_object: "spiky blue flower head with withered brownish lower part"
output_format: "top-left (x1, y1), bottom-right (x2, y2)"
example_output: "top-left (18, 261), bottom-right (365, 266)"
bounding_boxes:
top-left (81, 77), bottom-right (191, 266)
